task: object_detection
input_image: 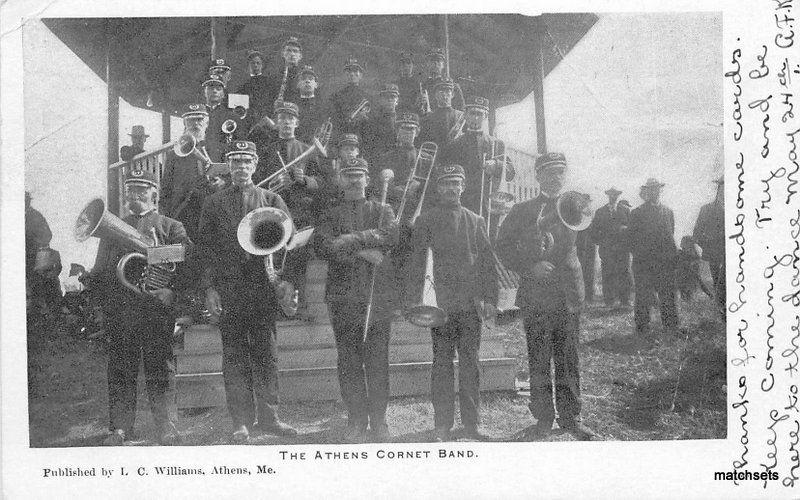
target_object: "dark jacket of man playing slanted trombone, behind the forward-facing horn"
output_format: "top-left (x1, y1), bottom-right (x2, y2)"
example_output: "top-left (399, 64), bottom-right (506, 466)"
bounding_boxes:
top-left (253, 138), bottom-right (322, 227)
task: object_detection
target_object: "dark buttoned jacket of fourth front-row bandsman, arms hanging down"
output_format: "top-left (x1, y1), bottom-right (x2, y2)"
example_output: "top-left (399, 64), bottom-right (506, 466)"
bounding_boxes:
top-left (407, 203), bottom-right (497, 312)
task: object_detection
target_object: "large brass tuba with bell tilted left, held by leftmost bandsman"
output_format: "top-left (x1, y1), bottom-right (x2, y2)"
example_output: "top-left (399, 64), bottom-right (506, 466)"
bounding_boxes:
top-left (74, 198), bottom-right (175, 294)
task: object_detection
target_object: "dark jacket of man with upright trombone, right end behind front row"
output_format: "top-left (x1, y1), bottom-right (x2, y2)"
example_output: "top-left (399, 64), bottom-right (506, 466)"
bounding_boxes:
top-left (437, 130), bottom-right (509, 212)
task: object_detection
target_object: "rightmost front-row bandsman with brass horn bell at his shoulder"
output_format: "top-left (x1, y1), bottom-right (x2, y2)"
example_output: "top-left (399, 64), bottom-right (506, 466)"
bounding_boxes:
top-left (496, 153), bottom-right (595, 440)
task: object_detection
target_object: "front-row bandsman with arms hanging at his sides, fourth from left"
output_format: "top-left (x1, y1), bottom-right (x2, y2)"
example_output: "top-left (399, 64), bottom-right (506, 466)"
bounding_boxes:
top-left (408, 165), bottom-right (497, 441)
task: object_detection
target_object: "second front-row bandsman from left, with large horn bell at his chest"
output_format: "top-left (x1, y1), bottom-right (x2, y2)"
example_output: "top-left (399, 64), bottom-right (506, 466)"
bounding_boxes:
top-left (198, 141), bottom-right (297, 443)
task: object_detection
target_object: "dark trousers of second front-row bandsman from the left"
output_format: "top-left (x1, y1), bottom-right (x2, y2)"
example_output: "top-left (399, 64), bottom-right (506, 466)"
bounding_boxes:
top-left (217, 282), bottom-right (278, 428)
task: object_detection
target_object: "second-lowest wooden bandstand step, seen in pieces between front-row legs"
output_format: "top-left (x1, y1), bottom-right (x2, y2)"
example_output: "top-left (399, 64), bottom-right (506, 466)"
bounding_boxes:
top-left (175, 336), bottom-right (505, 374)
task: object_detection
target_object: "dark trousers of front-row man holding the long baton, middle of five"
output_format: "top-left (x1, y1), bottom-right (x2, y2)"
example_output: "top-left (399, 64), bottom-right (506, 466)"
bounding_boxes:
top-left (328, 301), bottom-right (390, 429)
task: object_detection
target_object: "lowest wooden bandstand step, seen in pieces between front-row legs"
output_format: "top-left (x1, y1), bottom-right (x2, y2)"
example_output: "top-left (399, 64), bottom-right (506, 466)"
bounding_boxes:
top-left (175, 358), bottom-right (516, 408)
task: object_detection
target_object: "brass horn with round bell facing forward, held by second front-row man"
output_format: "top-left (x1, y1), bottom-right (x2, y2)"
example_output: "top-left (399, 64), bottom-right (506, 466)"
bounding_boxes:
top-left (236, 207), bottom-right (298, 317)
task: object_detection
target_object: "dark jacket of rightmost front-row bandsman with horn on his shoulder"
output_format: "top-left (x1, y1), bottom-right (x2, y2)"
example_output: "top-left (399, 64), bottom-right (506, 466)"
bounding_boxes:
top-left (496, 195), bottom-right (585, 311)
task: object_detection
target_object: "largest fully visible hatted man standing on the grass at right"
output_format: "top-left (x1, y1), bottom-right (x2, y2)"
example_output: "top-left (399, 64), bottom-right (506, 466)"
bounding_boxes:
top-left (628, 178), bottom-right (678, 334)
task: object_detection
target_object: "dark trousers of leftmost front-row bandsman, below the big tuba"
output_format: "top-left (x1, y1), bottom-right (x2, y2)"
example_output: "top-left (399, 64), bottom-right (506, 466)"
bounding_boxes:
top-left (106, 311), bottom-right (172, 435)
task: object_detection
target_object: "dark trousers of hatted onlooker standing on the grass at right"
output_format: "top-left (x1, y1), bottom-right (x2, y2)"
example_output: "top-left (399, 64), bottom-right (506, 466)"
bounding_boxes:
top-left (633, 260), bottom-right (678, 332)
